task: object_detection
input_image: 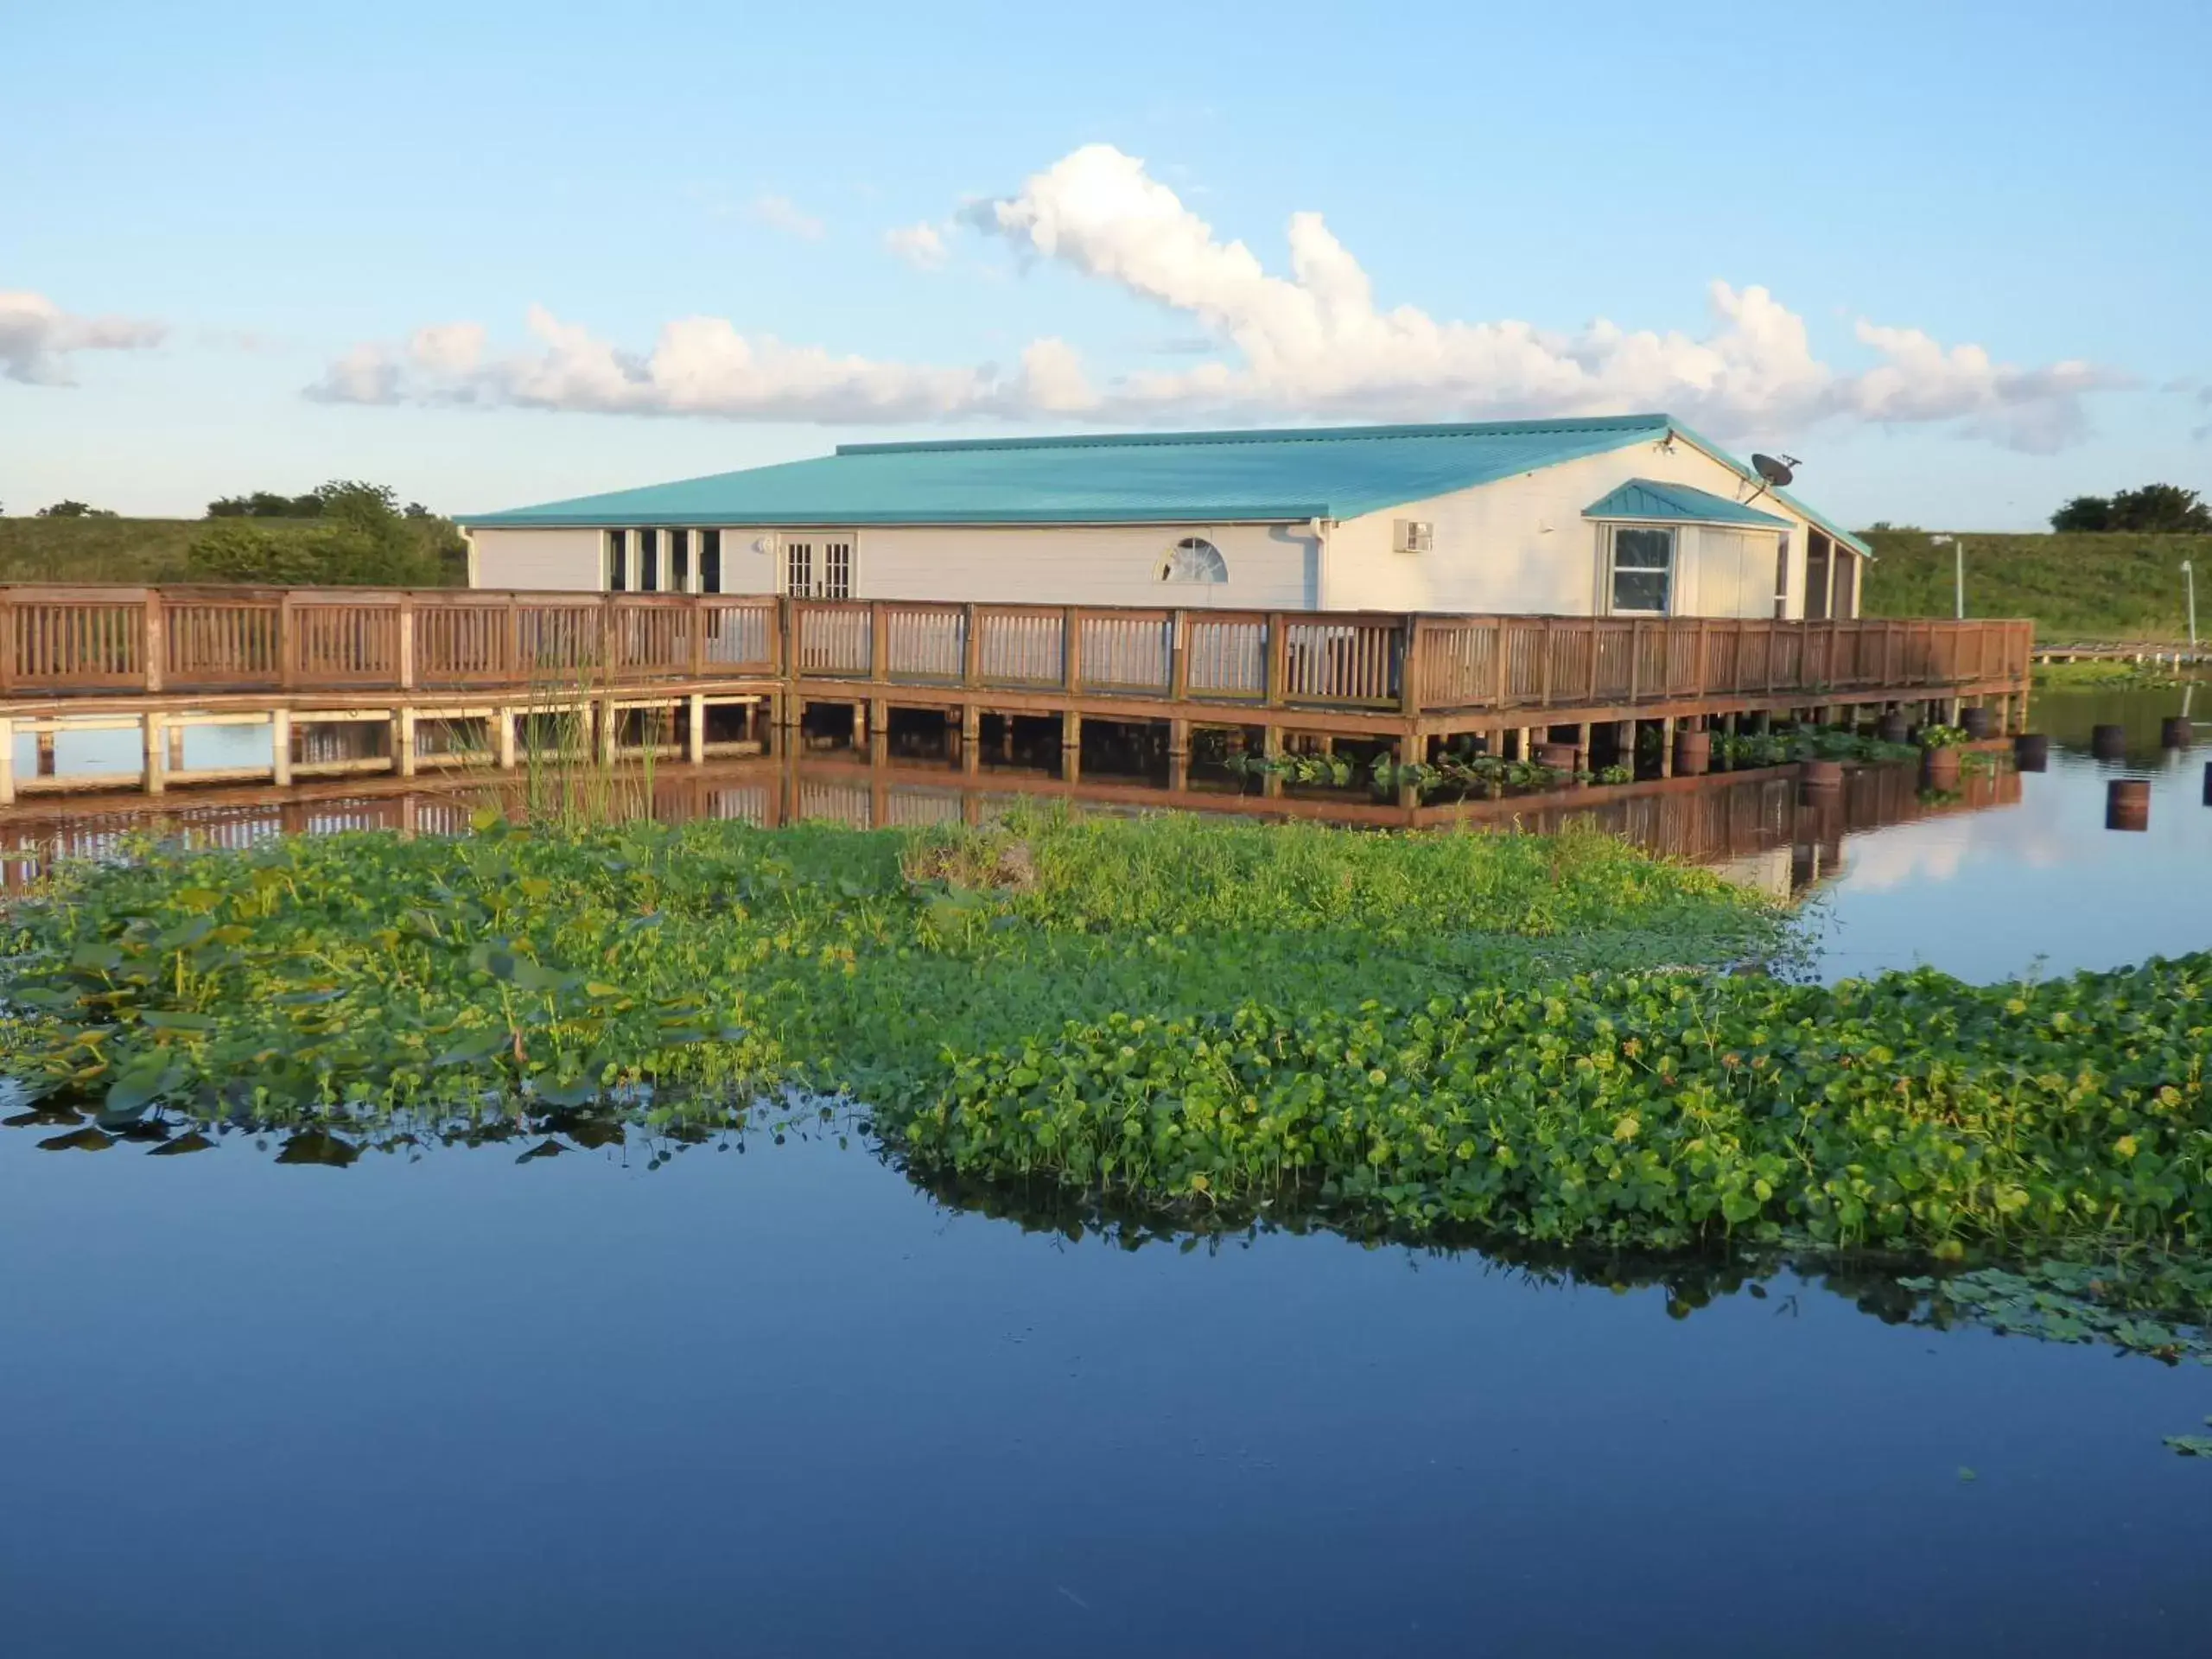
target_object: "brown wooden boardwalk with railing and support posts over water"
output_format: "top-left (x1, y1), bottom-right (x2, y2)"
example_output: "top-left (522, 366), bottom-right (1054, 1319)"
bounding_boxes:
top-left (0, 586), bottom-right (2033, 801)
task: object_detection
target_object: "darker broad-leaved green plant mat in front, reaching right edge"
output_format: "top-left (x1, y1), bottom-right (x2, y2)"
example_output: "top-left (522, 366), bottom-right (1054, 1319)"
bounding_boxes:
top-left (900, 956), bottom-right (2212, 1252)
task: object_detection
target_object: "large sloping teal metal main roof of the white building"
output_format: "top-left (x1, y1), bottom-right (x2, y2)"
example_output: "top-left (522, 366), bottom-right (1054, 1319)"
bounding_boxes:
top-left (460, 414), bottom-right (1672, 526)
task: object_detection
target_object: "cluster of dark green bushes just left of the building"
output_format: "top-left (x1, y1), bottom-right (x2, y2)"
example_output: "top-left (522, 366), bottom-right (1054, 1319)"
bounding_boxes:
top-left (186, 478), bottom-right (467, 588)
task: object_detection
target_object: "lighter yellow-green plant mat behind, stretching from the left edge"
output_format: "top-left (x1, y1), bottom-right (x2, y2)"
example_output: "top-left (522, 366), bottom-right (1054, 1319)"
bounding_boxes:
top-left (0, 814), bottom-right (1781, 1122)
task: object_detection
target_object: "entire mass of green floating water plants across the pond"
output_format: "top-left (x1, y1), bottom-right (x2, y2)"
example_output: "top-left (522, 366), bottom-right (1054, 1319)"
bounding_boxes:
top-left (0, 818), bottom-right (2212, 1255)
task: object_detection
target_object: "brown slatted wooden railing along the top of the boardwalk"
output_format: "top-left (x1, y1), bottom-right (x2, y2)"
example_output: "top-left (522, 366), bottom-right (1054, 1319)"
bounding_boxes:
top-left (0, 586), bottom-right (2033, 715)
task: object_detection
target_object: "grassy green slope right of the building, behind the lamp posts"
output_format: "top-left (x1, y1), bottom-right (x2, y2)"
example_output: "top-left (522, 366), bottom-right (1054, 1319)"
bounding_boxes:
top-left (1863, 531), bottom-right (2212, 644)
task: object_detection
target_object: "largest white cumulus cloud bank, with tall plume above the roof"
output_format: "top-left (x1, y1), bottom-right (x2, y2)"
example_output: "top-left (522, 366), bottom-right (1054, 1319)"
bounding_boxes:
top-left (315, 143), bottom-right (2126, 451)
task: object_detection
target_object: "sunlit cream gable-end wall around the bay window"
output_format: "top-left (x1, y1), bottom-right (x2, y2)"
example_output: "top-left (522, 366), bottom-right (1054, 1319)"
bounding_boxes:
top-left (1323, 440), bottom-right (1812, 617)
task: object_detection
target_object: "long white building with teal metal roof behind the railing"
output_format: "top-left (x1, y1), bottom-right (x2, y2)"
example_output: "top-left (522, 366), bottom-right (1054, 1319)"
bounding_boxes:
top-left (462, 414), bottom-right (1867, 620)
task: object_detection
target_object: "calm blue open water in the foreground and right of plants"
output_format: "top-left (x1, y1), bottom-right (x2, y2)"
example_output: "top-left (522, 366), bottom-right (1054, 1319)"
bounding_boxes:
top-left (0, 692), bottom-right (2212, 1659)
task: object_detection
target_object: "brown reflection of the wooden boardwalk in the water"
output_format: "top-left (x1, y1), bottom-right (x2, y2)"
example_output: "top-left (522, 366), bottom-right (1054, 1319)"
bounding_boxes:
top-left (0, 757), bottom-right (2019, 893)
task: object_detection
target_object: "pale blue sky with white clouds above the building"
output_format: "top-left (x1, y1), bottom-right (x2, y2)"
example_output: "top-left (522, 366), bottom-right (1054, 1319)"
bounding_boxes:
top-left (0, 0), bottom-right (2212, 529)
